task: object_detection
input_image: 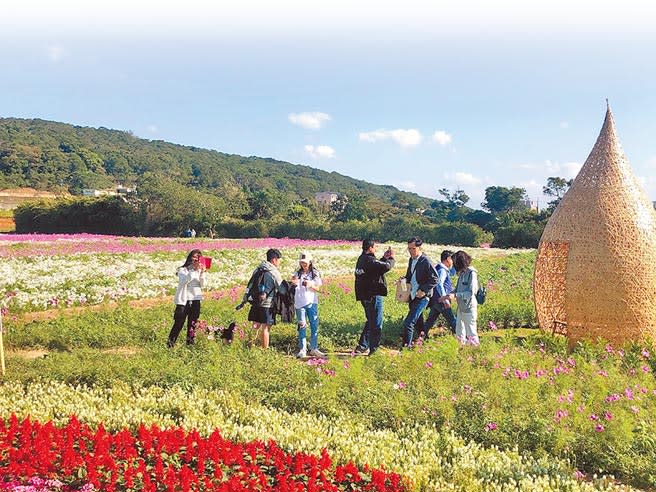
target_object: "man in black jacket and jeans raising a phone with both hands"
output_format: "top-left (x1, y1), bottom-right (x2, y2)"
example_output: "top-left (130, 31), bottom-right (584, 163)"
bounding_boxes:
top-left (355, 239), bottom-right (394, 355)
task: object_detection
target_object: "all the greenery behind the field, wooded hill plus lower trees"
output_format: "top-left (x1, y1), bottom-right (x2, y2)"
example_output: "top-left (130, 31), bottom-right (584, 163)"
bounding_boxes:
top-left (0, 118), bottom-right (569, 247)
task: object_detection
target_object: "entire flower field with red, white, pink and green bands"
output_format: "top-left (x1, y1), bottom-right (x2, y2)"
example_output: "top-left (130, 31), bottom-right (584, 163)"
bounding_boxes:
top-left (0, 236), bottom-right (656, 491)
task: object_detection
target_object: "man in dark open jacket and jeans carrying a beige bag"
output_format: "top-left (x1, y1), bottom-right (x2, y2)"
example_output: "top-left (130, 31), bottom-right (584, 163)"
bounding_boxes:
top-left (403, 237), bottom-right (437, 347)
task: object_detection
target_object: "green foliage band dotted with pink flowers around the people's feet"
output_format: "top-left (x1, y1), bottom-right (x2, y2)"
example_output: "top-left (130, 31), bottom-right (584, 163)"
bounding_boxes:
top-left (5, 253), bottom-right (656, 487)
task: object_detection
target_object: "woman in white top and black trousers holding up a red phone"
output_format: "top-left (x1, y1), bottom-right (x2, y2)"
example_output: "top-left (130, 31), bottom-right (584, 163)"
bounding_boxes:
top-left (167, 249), bottom-right (205, 347)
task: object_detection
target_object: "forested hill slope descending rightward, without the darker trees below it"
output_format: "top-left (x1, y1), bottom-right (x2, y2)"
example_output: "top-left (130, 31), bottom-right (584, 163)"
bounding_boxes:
top-left (0, 118), bottom-right (430, 208)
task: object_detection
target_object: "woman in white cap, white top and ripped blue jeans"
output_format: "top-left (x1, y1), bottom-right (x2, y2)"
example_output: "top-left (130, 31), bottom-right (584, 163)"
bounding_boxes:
top-left (292, 253), bottom-right (326, 358)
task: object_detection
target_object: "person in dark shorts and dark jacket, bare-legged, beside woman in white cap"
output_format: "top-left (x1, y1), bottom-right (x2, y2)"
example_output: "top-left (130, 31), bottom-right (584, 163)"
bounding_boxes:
top-left (242, 248), bottom-right (286, 349)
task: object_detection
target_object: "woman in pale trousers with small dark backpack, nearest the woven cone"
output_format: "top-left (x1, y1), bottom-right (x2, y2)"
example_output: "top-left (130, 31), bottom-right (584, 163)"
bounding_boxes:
top-left (447, 251), bottom-right (480, 345)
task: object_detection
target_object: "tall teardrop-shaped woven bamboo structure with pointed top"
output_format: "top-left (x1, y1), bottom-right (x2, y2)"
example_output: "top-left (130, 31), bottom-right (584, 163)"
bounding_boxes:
top-left (533, 107), bottom-right (656, 346)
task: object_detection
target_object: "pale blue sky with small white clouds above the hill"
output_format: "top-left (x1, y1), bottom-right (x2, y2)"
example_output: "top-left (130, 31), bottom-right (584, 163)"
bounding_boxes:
top-left (0, 0), bottom-right (656, 208)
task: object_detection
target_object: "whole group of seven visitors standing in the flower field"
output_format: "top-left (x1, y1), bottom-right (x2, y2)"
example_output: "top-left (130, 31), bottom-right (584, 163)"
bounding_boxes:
top-left (168, 237), bottom-right (479, 352)
